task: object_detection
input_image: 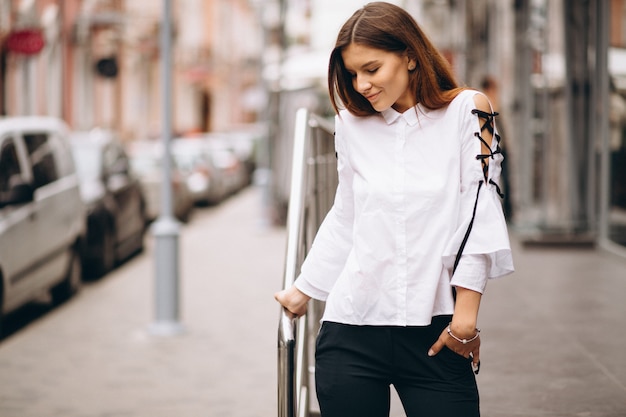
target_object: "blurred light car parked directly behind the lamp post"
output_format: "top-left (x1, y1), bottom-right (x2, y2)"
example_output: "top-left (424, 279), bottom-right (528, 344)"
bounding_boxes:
top-left (126, 141), bottom-right (194, 222)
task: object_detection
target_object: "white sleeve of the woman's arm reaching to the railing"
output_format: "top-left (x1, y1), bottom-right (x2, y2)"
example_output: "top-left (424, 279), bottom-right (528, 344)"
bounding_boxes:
top-left (294, 117), bottom-right (354, 301)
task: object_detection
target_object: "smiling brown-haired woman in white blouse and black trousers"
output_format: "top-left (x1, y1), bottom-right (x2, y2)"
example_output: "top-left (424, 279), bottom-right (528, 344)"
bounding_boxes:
top-left (275, 2), bottom-right (513, 417)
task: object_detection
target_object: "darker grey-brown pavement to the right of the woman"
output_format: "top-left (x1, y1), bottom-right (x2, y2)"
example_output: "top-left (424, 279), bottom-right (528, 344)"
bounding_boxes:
top-left (478, 237), bottom-right (626, 417)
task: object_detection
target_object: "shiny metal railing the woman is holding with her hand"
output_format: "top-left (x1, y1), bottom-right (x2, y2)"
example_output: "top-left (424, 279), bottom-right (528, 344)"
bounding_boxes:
top-left (278, 109), bottom-right (337, 417)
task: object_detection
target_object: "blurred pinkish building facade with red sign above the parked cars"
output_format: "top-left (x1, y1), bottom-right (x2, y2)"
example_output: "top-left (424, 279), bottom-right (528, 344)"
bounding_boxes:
top-left (0, 0), bottom-right (262, 140)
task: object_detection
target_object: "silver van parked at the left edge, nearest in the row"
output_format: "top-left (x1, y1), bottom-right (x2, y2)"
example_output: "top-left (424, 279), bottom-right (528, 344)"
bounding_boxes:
top-left (0, 117), bottom-right (85, 334)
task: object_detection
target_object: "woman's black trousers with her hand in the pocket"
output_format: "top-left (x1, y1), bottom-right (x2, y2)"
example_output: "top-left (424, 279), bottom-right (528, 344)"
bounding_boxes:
top-left (315, 316), bottom-right (480, 417)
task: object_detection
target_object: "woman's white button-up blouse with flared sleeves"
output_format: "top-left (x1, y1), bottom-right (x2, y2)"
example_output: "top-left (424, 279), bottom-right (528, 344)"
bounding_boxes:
top-left (295, 90), bottom-right (514, 326)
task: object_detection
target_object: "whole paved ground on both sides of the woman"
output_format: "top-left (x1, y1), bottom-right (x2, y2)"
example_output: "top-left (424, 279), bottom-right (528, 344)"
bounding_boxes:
top-left (0, 188), bottom-right (626, 417)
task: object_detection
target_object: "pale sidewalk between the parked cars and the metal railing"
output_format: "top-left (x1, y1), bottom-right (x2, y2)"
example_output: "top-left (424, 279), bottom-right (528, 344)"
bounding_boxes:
top-left (0, 188), bottom-right (285, 417)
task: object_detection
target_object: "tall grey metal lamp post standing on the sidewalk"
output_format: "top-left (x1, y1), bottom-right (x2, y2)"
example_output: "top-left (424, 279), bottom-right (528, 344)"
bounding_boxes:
top-left (150, 0), bottom-right (183, 336)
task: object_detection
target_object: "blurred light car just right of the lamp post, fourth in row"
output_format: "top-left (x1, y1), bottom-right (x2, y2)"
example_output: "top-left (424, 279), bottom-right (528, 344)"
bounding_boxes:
top-left (172, 138), bottom-right (228, 204)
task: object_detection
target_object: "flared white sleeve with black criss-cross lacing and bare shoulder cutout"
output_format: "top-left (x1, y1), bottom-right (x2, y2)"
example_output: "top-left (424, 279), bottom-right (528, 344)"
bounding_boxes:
top-left (443, 92), bottom-right (514, 293)
